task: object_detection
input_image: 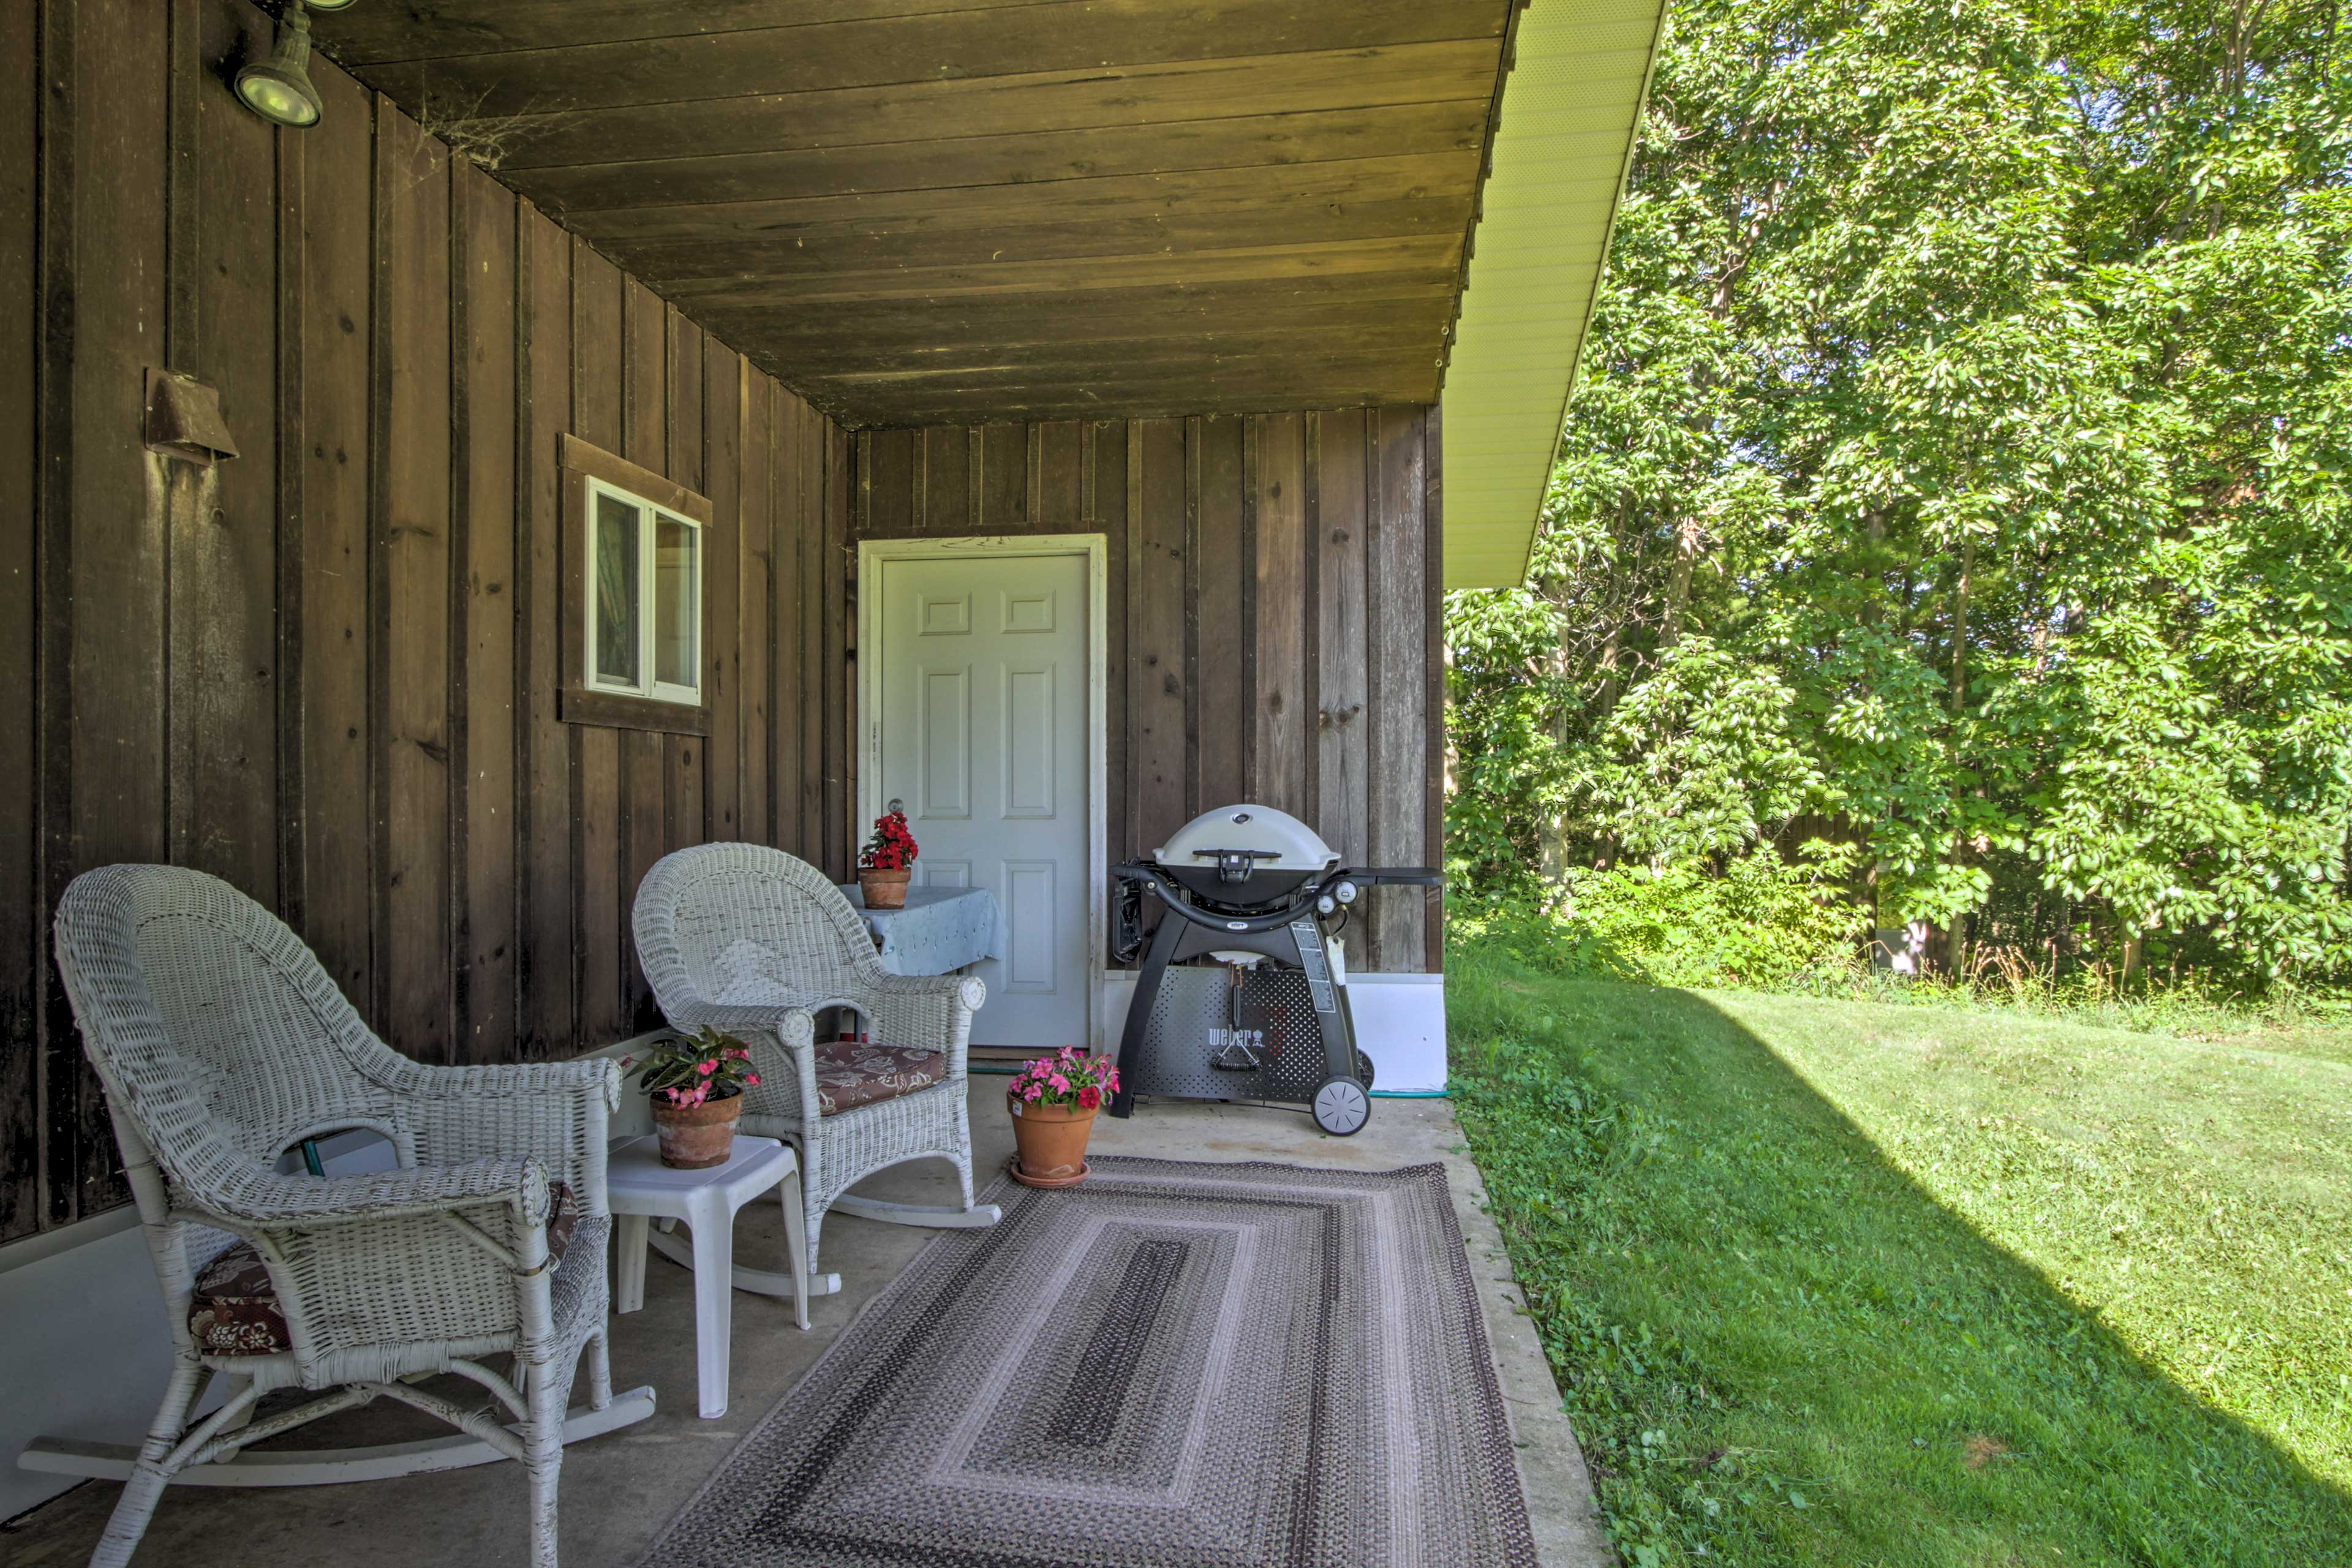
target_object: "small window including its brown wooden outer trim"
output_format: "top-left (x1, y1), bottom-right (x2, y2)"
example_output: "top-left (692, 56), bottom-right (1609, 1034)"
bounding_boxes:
top-left (557, 435), bottom-right (710, 736)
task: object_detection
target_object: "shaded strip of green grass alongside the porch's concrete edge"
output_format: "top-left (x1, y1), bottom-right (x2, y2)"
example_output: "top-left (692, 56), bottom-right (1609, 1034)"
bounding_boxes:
top-left (1447, 945), bottom-right (2352, 1568)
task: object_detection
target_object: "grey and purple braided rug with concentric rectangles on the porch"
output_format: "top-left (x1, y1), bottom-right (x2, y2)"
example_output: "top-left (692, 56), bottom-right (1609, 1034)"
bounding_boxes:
top-left (642, 1156), bottom-right (1536, 1568)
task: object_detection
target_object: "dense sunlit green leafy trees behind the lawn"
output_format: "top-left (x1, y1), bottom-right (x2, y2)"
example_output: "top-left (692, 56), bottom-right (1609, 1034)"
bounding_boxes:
top-left (1447, 0), bottom-right (2352, 978)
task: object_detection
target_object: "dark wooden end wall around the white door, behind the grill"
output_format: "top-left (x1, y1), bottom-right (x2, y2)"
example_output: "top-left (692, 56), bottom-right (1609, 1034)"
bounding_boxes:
top-left (846, 407), bottom-right (1444, 971)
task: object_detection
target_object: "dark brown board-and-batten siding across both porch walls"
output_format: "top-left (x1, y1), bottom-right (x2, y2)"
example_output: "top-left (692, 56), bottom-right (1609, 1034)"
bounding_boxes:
top-left (0, 0), bottom-right (1439, 1242)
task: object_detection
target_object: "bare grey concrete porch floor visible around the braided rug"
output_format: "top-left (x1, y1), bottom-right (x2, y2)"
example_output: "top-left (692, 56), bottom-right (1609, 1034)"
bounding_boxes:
top-left (0, 1077), bottom-right (1613, 1568)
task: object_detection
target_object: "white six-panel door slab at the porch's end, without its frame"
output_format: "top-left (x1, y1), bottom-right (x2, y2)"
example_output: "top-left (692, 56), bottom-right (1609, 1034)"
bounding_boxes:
top-left (863, 555), bottom-right (1094, 1049)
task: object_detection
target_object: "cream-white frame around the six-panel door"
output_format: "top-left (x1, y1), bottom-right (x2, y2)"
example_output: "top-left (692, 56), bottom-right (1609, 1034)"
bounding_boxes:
top-left (859, 533), bottom-right (1110, 1051)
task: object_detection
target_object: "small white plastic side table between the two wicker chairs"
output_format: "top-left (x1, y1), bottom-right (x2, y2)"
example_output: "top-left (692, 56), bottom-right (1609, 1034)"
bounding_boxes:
top-left (605, 1133), bottom-right (809, 1420)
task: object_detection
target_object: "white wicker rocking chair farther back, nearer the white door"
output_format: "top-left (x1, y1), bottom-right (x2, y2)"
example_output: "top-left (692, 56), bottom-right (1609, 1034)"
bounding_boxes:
top-left (635, 844), bottom-right (1000, 1295)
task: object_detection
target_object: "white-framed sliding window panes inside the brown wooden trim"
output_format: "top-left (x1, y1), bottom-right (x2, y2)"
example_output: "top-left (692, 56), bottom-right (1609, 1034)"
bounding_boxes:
top-left (588, 480), bottom-right (703, 705)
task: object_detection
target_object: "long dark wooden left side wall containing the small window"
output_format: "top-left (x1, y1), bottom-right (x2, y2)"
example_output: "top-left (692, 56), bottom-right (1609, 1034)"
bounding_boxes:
top-left (0, 0), bottom-right (849, 1242)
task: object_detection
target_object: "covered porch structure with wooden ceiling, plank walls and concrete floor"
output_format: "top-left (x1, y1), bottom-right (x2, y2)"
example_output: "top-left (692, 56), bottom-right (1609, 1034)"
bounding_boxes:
top-left (0, 0), bottom-right (1663, 1563)
